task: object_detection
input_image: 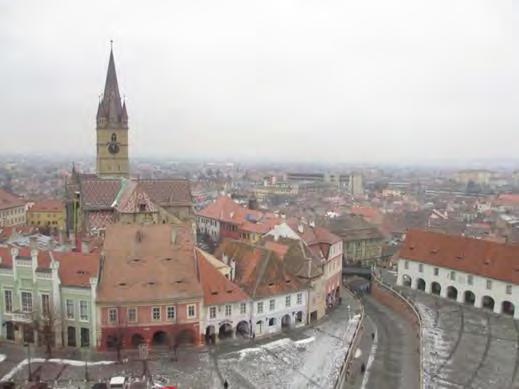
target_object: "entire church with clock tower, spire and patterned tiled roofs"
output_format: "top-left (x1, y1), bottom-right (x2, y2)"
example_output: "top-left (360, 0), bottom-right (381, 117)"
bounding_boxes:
top-left (66, 46), bottom-right (192, 237)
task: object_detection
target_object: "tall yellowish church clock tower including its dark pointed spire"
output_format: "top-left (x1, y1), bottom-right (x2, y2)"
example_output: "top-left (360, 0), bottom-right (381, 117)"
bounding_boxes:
top-left (96, 48), bottom-right (130, 178)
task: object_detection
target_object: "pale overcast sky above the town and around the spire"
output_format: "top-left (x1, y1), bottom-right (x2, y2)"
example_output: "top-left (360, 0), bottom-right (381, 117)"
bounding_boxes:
top-left (0, 0), bottom-right (519, 162)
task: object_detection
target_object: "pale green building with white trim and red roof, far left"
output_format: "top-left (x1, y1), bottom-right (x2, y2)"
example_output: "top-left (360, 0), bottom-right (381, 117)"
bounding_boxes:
top-left (0, 247), bottom-right (99, 348)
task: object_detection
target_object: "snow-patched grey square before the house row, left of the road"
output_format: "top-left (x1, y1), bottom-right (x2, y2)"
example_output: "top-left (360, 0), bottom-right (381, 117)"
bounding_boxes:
top-left (0, 293), bottom-right (360, 389)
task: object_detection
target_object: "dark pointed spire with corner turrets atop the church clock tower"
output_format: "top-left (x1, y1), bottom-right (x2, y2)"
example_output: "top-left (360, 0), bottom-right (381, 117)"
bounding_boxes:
top-left (97, 41), bottom-right (127, 128)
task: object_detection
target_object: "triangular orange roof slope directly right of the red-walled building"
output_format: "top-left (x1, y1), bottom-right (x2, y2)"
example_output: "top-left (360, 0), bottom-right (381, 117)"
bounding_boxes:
top-left (196, 249), bottom-right (249, 305)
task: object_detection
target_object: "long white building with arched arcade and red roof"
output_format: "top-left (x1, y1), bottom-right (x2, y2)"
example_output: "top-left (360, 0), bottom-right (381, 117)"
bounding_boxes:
top-left (397, 230), bottom-right (519, 319)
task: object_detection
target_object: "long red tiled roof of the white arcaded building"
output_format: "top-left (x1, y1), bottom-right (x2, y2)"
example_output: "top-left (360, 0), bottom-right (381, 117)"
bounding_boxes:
top-left (399, 230), bottom-right (519, 284)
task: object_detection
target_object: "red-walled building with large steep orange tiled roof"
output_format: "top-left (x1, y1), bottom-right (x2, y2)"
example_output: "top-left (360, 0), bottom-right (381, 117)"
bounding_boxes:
top-left (96, 223), bottom-right (203, 350)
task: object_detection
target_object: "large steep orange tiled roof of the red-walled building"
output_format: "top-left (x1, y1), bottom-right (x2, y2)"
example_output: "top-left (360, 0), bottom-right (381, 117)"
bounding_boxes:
top-left (98, 223), bottom-right (203, 303)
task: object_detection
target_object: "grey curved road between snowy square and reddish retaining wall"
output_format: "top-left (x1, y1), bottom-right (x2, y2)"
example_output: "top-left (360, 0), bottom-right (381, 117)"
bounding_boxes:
top-left (345, 295), bottom-right (420, 389)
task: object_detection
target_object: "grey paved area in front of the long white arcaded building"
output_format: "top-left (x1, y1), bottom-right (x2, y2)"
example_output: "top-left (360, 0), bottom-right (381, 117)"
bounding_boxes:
top-left (399, 287), bottom-right (519, 389)
